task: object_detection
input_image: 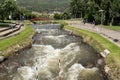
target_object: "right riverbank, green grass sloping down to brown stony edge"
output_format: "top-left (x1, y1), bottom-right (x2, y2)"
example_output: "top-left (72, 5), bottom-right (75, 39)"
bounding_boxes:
top-left (64, 26), bottom-right (120, 80)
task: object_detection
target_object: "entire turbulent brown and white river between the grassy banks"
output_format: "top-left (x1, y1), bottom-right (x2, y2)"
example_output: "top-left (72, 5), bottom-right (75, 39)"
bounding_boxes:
top-left (0, 29), bottom-right (104, 80)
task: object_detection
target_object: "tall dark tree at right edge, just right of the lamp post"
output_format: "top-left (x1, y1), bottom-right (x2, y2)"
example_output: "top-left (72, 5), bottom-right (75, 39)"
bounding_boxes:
top-left (94, 0), bottom-right (120, 25)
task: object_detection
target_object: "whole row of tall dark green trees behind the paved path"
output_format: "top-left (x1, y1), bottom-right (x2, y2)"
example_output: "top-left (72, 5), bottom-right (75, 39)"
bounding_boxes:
top-left (70, 0), bottom-right (120, 25)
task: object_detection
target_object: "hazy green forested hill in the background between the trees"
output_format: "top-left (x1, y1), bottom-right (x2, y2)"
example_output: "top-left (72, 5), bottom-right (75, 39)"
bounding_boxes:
top-left (17, 0), bottom-right (71, 12)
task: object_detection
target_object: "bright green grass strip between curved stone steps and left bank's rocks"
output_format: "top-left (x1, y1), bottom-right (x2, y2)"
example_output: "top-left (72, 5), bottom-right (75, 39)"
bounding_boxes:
top-left (0, 25), bottom-right (34, 51)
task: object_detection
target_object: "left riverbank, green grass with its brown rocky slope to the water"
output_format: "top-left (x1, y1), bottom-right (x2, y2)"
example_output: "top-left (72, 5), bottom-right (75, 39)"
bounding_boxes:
top-left (0, 24), bottom-right (34, 61)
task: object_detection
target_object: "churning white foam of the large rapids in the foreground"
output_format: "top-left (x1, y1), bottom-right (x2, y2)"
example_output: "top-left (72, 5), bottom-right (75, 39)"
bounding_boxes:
top-left (13, 42), bottom-right (99, 80)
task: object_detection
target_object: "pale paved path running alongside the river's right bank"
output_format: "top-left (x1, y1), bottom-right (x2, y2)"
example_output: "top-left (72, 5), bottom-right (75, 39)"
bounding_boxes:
top-left (67, 21), bottom-right (120, 47)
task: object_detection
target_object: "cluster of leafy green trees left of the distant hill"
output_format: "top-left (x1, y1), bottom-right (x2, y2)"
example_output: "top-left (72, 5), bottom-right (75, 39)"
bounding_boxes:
top-left (0, 0), bottom-right (36, 21)
